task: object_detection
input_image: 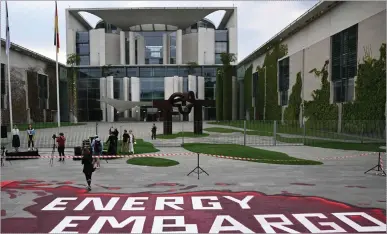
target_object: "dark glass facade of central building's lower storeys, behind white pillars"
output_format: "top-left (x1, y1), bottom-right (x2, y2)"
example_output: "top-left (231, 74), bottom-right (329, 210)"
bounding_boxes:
top-left (77, 66), bottom-right (224, 121)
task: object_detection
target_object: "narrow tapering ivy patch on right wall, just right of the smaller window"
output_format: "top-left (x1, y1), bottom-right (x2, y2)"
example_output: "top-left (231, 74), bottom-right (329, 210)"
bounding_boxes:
top-left (284, 72), bottom-right (302, 123)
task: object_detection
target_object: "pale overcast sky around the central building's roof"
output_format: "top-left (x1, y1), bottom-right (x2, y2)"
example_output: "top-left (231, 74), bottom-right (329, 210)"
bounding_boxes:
top-left (1, 0), bottom-right (317, 63)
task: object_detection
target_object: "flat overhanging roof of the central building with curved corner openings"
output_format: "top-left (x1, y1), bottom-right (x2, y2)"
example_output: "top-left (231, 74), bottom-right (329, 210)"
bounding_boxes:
top-left (67, 7), bottom-right (236, 30)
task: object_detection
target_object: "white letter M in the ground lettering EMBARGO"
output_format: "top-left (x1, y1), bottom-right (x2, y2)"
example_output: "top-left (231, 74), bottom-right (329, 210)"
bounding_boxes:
top-left (88, 216), bottom-right (146, 233)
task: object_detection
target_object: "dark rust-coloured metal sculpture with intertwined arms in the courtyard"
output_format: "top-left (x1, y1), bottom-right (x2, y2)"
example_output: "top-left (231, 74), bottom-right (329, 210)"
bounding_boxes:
top-left (153, 91), bottom-right (215, 135)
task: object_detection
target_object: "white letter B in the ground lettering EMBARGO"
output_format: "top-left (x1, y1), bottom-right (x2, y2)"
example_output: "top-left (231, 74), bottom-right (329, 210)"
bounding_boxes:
top-left (152, 216), bottom-right (198, 233)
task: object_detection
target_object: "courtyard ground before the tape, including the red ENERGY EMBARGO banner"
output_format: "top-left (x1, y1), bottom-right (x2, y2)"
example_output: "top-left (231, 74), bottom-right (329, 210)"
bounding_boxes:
top-left (1, 137), bottom-right (386, 233)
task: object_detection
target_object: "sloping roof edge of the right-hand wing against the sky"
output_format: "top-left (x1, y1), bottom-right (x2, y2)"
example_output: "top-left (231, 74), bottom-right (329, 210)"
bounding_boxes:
top-left (238, 1), bottom-right (342, 66)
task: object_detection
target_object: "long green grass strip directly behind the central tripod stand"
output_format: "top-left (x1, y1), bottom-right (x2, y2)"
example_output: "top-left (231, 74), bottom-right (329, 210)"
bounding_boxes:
top-left (183, 143), bottom-right (322, 165)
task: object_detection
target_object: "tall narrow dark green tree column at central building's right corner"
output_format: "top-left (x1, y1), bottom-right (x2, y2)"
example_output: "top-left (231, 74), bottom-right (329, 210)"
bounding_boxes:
top-left (220, 53), bottom-right (236, 120)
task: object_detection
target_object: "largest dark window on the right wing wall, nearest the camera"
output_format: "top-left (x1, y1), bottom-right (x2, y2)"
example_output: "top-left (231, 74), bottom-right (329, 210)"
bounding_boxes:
top-left (331, 25), bottom-right (358, 102)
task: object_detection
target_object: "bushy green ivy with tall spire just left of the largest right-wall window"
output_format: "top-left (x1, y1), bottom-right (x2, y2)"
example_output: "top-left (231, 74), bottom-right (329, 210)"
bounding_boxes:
top-left (304, 60), bottom-right (338, 131)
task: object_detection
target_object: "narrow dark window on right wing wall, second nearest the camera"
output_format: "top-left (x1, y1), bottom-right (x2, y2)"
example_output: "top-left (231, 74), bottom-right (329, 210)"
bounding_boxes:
top-left (278, 57), bottom-right (289, 106)
